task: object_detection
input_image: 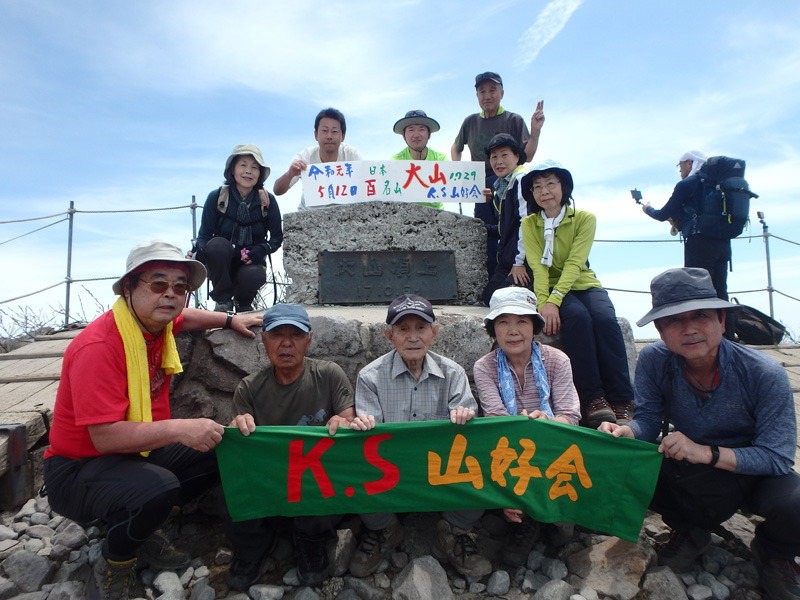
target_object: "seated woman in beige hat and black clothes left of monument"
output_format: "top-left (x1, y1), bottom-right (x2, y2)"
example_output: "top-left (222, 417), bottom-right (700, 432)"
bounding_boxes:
top-left (189, 144), bottom-right (283, 312)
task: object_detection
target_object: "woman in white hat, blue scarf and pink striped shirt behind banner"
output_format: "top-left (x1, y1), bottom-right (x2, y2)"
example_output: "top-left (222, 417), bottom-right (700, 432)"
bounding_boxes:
top-left (474, 287), bottom-right (581, 567)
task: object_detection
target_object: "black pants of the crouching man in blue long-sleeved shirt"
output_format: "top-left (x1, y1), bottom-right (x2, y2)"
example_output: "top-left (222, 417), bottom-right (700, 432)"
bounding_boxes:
top-left (650, 458), bottom-right (800, 558)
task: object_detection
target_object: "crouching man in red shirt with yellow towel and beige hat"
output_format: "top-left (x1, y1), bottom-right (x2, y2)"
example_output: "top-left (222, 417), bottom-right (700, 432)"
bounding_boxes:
top-left (44, 241), bottom-right (261, 599)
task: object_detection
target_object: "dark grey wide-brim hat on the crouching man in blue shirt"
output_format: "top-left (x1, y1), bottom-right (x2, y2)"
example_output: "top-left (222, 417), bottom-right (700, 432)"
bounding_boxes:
top-left (636, 267), bottom-right (739, 327)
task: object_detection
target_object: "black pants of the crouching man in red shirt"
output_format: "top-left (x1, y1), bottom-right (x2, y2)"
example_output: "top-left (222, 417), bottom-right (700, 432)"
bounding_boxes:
top-left (44, 444), bottom-right (219, 560)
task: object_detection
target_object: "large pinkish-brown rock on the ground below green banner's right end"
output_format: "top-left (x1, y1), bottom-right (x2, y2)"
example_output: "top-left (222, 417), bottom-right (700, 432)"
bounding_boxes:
top-left (567, 538), bottom-right (655, 600)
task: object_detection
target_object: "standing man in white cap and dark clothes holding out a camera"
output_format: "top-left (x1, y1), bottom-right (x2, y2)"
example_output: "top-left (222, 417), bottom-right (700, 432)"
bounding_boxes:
top-left (642, 150), bottom-right (736, 340)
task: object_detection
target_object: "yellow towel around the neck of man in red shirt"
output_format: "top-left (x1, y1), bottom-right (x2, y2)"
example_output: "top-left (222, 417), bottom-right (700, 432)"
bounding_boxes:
top-left (111, 296), bottom-right (183, 456)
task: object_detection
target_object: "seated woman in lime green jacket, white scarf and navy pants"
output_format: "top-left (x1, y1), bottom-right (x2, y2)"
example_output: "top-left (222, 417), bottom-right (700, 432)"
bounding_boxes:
top-left (520, 160), bottom-right (633, 429)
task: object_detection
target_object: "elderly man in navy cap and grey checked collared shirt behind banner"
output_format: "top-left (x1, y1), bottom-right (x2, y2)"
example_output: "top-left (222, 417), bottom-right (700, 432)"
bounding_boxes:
top-left (350, 294), bottom-right (492, 577)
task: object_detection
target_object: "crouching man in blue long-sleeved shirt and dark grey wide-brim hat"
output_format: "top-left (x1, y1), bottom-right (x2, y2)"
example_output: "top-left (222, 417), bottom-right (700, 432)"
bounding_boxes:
top-left (599, 268), bottom-right (800, 600)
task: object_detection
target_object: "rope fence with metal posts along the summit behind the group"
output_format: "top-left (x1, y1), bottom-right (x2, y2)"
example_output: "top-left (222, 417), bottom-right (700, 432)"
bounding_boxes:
top-left (0, 196), bottom-right (800, 326)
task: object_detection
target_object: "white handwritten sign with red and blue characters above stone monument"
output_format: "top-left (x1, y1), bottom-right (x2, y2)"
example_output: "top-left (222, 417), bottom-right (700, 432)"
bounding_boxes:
top-left (301, 160), bottom-right (485, 206)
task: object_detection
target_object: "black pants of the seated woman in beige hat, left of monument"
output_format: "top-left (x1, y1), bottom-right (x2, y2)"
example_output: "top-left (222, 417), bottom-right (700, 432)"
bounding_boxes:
top-left (202, 237), bottom-right (267, 305)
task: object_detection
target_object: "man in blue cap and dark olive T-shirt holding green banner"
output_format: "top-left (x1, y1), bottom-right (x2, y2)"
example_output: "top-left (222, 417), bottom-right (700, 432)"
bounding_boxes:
top-left (225, 304), bottom-right (355, 590)
